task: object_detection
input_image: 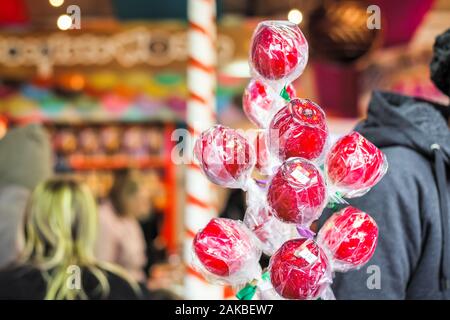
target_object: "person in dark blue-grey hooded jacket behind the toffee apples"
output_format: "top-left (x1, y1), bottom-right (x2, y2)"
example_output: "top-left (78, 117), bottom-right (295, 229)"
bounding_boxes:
top-left (320, 29), bottom-right (450, 299)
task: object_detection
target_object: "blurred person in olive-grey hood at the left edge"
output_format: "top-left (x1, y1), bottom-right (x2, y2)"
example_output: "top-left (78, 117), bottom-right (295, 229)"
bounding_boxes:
top-left (0, 124), bottom-right (52, 269)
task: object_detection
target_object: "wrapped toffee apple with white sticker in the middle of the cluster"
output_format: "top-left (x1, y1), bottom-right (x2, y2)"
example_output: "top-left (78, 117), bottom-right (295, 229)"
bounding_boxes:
top-left (267, 158), bottom-right (326, 227)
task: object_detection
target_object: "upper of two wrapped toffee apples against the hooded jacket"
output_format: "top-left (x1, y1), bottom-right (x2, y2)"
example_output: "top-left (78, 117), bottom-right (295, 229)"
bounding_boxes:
top-left (325, 131), bottom-right (388, 198)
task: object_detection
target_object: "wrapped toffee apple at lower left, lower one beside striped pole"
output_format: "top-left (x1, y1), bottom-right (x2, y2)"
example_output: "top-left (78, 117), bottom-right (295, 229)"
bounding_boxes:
top-left (193, 218), bottom-right (261, 285)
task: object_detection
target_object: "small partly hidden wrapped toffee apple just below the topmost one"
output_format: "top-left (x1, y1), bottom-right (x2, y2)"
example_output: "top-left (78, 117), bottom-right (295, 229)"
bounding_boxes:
top-left (242, 80), bottom-right (297, 128)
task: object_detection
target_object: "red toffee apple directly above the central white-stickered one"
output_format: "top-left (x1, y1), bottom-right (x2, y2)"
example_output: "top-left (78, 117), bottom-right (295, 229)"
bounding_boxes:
top-left (268, 99), bottom-right (328, 161)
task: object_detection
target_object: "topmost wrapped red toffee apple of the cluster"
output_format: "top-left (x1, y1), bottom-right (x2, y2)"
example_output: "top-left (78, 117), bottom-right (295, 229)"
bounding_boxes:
top-left (250, 21), bottom-right (308, 80)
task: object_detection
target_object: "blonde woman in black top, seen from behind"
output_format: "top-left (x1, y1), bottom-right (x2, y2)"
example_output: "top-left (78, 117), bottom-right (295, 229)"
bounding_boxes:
top-left (0, 179), bottom-right (149, 300)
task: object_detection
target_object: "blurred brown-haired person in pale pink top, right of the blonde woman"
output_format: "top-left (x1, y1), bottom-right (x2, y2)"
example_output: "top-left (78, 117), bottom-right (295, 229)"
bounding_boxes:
top-left (95, 169), bottom-right (151, 281)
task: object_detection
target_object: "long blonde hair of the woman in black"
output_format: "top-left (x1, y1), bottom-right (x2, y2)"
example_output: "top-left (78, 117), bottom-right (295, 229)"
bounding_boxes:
top-left (20, 178), bottom-right (139, 300)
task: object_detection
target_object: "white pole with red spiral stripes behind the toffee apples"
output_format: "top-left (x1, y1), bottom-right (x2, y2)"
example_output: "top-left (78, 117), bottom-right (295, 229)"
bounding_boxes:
top-left (184, 0), bottom-right (223, 299)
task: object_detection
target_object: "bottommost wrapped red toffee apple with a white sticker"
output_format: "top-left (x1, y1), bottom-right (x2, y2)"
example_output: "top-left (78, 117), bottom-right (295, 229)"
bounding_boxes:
top-left (269, 239), bottom-right (331, 300)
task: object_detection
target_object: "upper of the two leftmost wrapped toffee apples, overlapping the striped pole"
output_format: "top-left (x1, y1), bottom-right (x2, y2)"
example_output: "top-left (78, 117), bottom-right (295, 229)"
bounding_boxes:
top-left (194, 125), bottom-right (256, 189)
